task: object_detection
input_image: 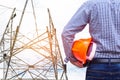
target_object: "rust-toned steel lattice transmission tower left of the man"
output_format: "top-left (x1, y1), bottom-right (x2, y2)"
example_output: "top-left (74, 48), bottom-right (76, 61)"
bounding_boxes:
top-left (0, 0), bottom-right (68, 80)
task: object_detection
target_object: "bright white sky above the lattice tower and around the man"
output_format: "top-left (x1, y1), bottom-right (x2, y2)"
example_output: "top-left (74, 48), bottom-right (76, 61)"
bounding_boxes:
top-left (0, 0), bottom-right (89, 80)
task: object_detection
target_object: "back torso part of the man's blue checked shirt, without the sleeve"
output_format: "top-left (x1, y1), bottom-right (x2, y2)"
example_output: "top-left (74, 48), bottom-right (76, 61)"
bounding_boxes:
top-left (87, 0), bottom-right (120, 58)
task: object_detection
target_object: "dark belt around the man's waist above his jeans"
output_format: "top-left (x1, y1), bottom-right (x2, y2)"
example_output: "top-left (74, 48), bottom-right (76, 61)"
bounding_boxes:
top-left (90, 58), bottom-right (120, 64)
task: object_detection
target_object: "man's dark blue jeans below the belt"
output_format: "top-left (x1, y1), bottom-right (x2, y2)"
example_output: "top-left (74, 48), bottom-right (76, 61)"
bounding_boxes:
top-left (85, 59), bottom-right (120, 80)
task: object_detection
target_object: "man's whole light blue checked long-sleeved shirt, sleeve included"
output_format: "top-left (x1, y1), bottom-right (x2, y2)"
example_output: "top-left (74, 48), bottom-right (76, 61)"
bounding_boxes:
top-left (62, 0), bottom-right (120, 62)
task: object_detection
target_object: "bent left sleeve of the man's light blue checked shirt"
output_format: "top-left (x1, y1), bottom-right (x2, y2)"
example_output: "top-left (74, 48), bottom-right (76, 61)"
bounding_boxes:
top-left (61, 3), bottom-right (90, 62)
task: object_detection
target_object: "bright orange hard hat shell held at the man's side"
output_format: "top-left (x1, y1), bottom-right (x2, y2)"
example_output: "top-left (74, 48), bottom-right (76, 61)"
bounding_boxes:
top-left (72, 38), bottom-right (96, 64)
